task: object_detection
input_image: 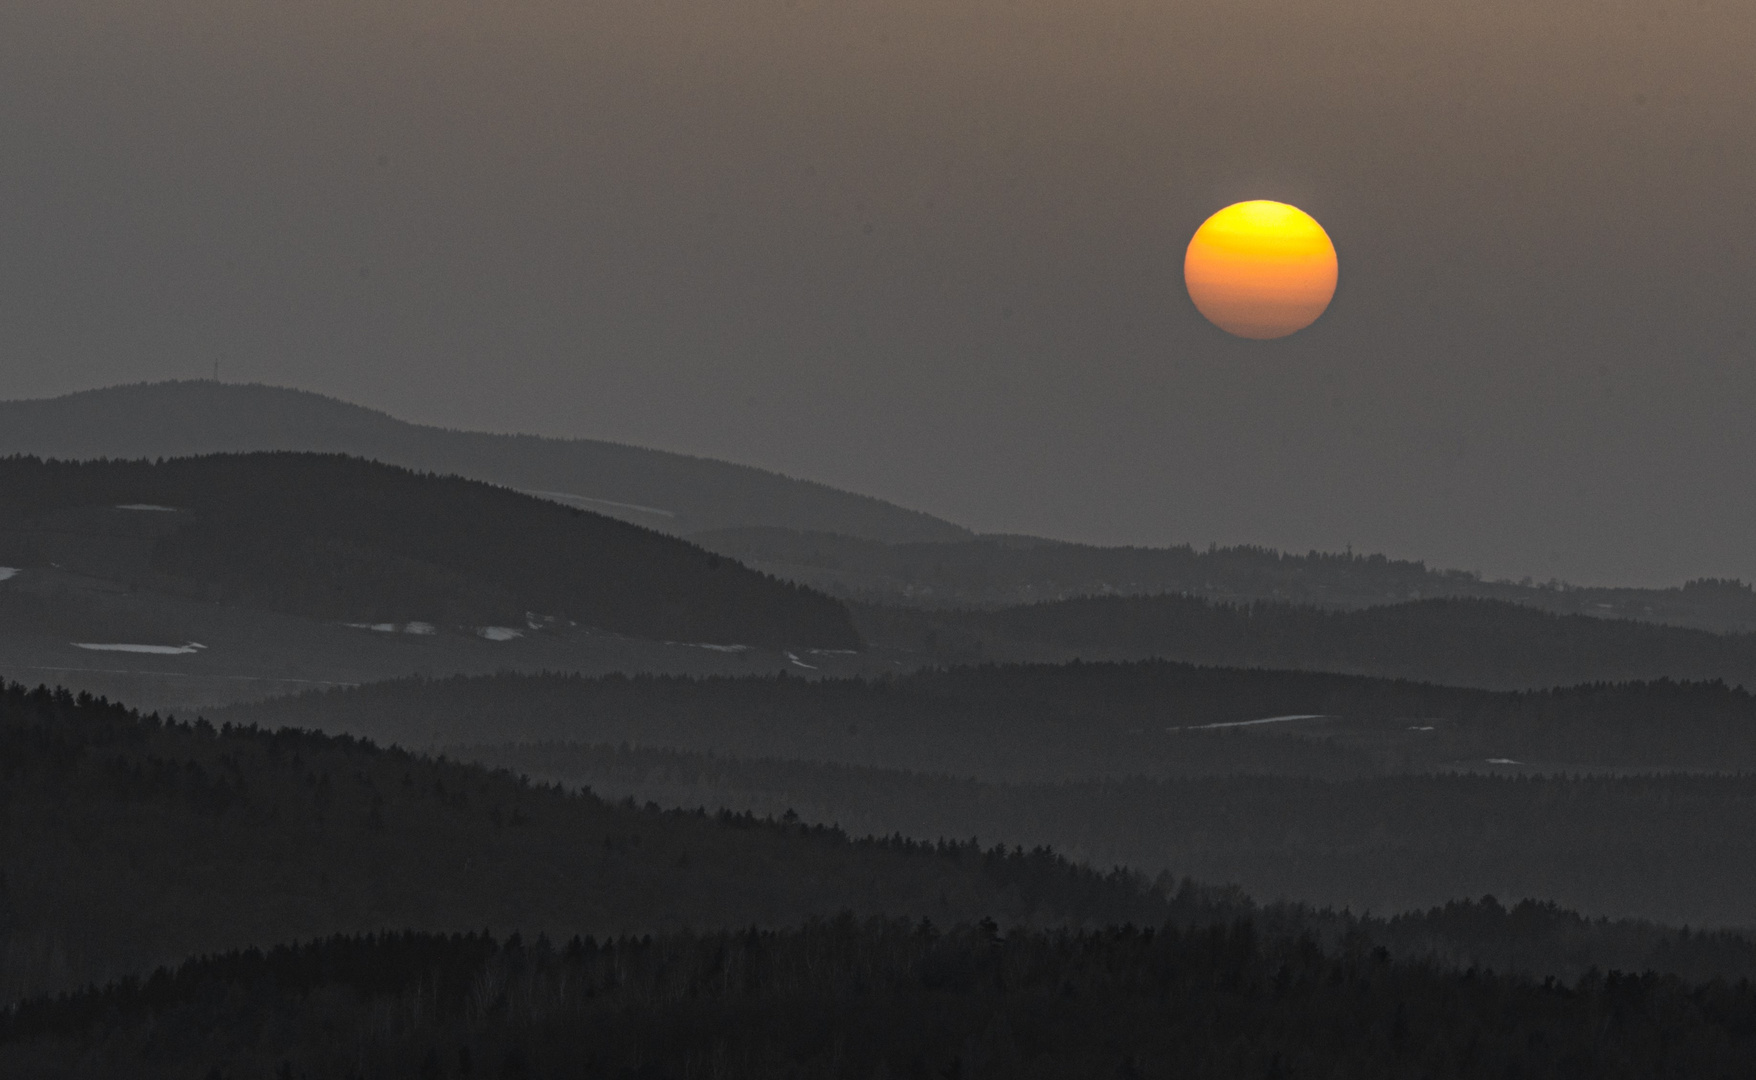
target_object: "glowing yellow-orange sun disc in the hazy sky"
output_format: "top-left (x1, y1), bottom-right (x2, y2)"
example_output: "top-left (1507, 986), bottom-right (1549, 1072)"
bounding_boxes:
top-left (1184, 198), bottom-right (1336, 341)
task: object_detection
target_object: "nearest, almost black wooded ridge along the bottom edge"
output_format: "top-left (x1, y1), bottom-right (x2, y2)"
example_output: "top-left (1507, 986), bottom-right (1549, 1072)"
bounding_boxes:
top-left (10, 917), bottom-right (1756, 1080)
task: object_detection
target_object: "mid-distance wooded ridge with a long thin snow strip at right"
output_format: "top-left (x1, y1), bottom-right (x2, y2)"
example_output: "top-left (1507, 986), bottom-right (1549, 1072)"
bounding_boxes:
top-left (214, 660), bottom-right (1756, 781)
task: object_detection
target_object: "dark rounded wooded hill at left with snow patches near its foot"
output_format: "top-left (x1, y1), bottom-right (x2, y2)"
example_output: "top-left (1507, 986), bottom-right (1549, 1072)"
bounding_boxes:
top-left (0, 453), bottom-right (859, 648)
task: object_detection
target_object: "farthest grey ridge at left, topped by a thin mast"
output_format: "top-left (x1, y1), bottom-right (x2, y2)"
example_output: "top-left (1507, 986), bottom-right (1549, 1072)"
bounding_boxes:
top-left (0, 381), bottom-right (973, 541)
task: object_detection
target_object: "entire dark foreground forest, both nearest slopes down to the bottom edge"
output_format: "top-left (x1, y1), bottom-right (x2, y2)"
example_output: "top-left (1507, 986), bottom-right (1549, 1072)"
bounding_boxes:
top-left (17, 685), bottom-right (1756, 1080)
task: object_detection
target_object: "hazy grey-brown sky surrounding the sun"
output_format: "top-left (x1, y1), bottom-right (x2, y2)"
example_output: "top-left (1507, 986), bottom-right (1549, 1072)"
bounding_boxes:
top-left (0, 0), bottom-right (1756, 583)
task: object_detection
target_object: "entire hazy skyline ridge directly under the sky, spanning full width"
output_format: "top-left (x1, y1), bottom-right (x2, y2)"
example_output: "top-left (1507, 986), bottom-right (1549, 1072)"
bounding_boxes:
top-left (17, 381), bottom-right (1756, 634)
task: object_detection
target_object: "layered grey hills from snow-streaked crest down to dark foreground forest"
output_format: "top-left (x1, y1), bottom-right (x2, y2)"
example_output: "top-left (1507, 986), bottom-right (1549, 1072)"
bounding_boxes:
top-left (214, 662), bottom-right (1756, 927)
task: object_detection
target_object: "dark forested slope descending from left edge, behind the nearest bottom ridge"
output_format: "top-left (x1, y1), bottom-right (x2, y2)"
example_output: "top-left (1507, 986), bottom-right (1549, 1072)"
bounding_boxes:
top-left (0, 685), bottom-right (1166, 1006)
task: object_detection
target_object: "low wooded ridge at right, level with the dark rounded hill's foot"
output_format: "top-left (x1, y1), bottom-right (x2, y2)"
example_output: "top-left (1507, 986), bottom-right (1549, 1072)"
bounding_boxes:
top-left (855, 595), bottom-right (1756, 690)
